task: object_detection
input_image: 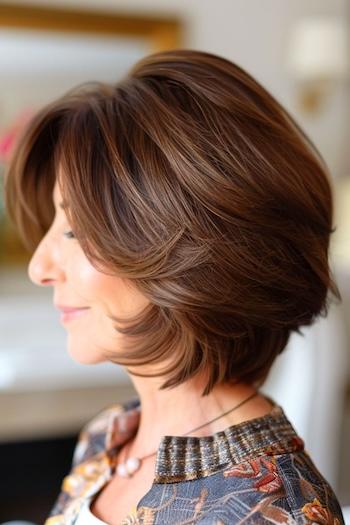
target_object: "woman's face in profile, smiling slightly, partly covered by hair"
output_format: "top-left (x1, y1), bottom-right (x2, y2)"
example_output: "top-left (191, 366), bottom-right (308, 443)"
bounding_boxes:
top-left (28, 182), bottom-right (149, 363)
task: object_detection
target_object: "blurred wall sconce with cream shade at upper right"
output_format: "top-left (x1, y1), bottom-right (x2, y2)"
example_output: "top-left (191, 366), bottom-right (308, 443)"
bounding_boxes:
top-left (287, 17), bottom-right (349, 113)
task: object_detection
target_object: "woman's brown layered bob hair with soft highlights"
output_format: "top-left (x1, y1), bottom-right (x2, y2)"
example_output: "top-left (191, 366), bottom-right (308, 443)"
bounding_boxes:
top-left (5, 49), bottom-right (341, 395)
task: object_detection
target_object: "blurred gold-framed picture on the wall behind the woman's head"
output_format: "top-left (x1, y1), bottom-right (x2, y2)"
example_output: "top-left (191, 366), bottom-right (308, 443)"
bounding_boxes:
top-left (0, 3), bottom-right (182, 265)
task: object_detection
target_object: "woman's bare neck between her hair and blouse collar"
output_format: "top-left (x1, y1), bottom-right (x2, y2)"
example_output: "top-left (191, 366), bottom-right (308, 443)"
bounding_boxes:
top-left (123, 366), bottom-right (272, 456)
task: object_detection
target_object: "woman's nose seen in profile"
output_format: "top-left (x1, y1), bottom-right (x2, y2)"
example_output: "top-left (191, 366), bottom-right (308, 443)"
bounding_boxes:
top-left (28, 234), bottom-right (64, 286)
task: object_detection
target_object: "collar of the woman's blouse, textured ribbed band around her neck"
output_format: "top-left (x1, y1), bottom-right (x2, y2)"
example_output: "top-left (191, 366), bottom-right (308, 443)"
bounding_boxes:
top-left (105, 395), bottom-right (304, 483)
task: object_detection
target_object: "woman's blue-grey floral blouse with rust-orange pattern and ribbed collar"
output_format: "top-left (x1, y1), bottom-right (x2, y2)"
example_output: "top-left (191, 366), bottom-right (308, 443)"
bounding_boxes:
top-left (45, 396), bottom-right (344, 525)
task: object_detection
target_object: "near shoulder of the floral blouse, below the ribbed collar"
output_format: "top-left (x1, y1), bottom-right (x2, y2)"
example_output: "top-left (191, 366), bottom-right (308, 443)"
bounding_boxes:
top-left (138, 451), bottom-right (344, 525)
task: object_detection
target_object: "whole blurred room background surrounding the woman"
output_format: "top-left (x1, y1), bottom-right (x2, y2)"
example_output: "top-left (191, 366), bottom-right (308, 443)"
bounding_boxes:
top-left (0, 0), bottom-right (350, 522)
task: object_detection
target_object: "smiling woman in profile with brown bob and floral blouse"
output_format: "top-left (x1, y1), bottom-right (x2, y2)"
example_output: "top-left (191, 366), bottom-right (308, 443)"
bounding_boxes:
top-left (6, 49), bottom-right (343, 525)
